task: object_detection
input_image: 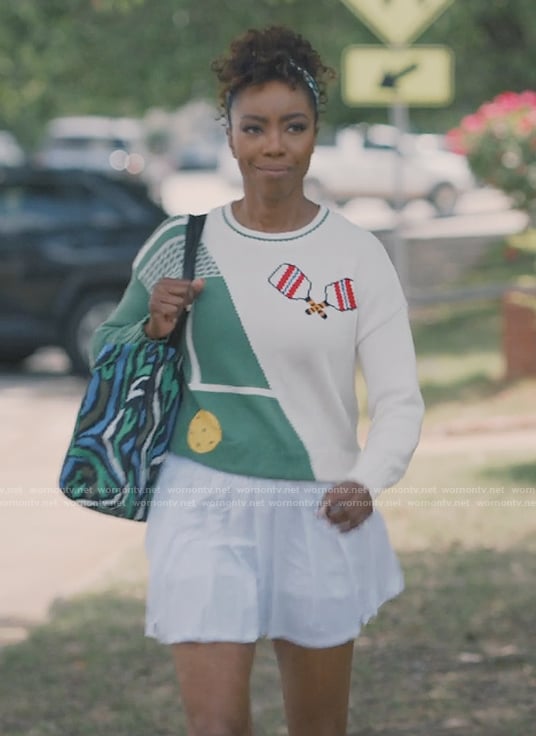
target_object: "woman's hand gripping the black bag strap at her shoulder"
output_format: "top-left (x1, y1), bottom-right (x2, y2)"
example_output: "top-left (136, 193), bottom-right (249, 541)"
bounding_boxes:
top-left (144, 278), bottom-right (205, 340)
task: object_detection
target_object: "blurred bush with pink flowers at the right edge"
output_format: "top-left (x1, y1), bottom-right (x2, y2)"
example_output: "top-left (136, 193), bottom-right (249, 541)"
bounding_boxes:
top-left (447, 90), bottom-right (536, 225)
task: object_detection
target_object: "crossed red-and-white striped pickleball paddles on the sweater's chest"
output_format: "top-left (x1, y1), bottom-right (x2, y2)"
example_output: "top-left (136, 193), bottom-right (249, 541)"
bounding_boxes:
top-left (268, 263), bottom-right (357, 319)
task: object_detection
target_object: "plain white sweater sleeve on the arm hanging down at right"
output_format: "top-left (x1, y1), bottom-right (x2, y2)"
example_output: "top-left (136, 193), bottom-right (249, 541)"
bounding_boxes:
top-left (349, 306), bottom-right (424, 497)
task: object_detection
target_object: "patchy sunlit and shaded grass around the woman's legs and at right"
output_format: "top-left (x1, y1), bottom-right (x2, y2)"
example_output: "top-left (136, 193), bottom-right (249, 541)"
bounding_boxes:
top-left (0, 304), bottom-right (536, 736)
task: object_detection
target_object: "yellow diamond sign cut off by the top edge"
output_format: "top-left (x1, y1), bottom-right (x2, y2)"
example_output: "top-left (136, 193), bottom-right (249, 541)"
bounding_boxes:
top-left (342, 0), bottom-right (454, 44)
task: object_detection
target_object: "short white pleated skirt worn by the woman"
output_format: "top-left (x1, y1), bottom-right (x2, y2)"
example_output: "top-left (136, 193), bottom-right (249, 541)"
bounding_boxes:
top-left (145, 454), bottom-right (404, 648)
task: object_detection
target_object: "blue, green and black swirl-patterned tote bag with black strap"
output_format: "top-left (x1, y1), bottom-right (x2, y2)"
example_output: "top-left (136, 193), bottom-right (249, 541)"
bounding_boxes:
top-left (60, 215), bottom-right (205, 521)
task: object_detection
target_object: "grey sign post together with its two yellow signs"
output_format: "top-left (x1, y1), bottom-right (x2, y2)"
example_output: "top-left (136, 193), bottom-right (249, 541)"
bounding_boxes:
top-left (341, 0), bottom-right (454, 294)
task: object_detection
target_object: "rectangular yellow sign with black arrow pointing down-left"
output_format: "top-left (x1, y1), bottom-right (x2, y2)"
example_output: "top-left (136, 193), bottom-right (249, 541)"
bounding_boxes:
top-left (342, 46), bottom-right (454, 107)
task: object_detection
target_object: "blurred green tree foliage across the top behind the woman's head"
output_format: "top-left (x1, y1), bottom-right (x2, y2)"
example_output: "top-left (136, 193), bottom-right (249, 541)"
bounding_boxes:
top-left (0, 0), bottom-right (536, 144)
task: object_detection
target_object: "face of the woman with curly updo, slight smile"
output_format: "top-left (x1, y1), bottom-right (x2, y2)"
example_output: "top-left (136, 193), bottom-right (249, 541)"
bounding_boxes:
top-left (228, 80), bottom-right (317, 199)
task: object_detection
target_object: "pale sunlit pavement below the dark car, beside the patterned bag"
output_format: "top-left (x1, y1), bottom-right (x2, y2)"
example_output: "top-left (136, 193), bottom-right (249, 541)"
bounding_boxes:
top-left (0, 362), bottom-right (144, 644)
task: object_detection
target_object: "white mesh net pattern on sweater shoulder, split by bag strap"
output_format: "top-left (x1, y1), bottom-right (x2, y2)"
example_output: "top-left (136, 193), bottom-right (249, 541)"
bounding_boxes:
top-left (138, 235), bottom-right (220, 293)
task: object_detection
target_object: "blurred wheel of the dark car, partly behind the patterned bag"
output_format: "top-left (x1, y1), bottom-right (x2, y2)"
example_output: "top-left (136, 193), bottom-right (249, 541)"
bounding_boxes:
top-left (65, 292), bottom-right (120, 375)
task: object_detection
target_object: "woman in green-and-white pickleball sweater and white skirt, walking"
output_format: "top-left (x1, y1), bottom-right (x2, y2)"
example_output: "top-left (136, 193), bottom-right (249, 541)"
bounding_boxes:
top-left (95, 27), bottom-right (423, 736)
